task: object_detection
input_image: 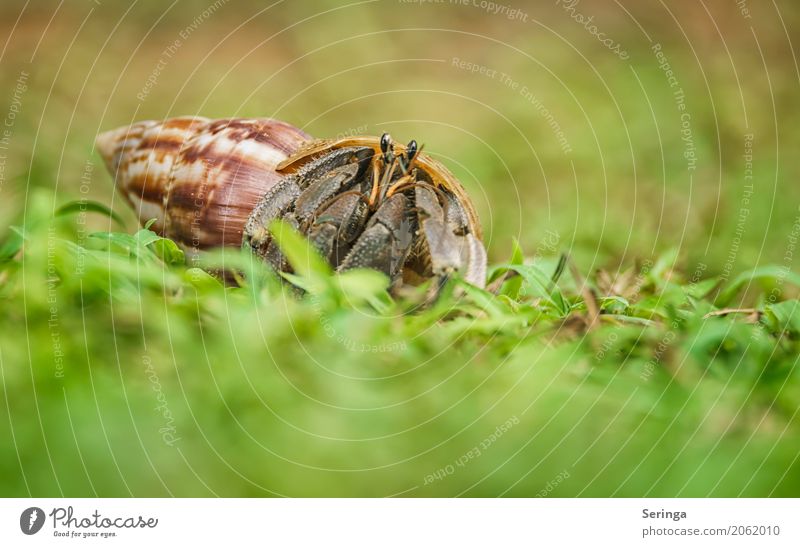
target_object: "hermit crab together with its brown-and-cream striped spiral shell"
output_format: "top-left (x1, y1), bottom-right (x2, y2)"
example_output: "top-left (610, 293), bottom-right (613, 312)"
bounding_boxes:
top-left (97, 117), bottom-right (486, 294)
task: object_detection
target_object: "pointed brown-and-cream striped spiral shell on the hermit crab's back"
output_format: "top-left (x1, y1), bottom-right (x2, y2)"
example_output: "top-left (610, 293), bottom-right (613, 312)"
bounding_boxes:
top-left (96, 117), bottom-right (310, 248)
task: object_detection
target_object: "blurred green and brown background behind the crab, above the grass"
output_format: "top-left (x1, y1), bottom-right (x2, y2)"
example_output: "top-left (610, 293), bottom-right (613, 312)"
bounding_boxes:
top-left (1, 0), bottom-right (800, 271)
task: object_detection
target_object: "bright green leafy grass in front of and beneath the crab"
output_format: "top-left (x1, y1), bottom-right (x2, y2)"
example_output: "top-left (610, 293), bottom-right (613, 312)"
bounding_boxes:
top-left (0, 194), bottom-right (800, 496)
